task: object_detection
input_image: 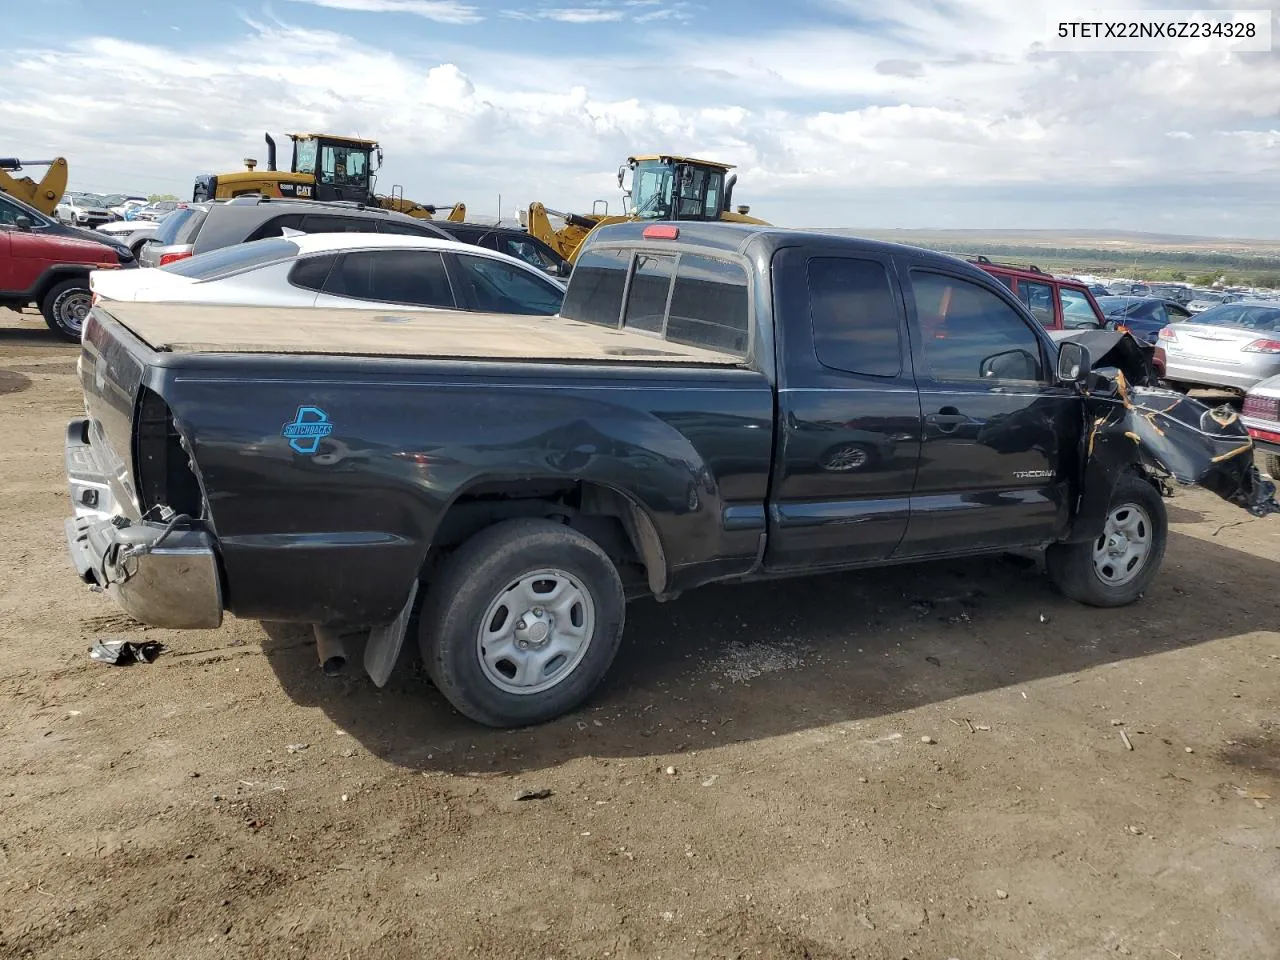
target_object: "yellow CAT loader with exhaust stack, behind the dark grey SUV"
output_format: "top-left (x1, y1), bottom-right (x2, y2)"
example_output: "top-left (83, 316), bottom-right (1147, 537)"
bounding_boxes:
top-left (191, 133), bottom-right (467, 223)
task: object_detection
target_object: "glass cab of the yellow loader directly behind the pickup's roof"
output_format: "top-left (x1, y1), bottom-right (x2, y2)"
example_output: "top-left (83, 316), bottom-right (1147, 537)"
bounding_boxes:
top-left (618, 156), bottom-right (746, 220)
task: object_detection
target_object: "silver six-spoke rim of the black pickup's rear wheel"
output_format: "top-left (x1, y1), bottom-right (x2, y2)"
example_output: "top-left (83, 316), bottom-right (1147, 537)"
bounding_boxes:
top-left (476, 567), bottom-right (595, 696)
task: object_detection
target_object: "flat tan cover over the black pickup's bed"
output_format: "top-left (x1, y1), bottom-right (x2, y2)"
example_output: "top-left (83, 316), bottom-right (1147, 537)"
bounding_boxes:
top-left (104, 301), bottom-right (745, 366)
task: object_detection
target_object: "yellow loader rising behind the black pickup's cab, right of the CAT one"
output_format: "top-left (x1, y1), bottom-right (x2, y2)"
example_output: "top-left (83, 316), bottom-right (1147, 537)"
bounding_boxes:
top-left (520, 154), bottom-right (765, 262)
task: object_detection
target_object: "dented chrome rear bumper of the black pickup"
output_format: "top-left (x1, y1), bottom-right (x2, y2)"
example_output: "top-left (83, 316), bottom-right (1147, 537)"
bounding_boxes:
top-left (65, 421), bottom-right (223, 628)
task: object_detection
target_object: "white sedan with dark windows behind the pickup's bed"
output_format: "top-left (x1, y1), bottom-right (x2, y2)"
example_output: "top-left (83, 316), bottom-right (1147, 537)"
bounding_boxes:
top-left (90, 232), bottom-right (564, 316)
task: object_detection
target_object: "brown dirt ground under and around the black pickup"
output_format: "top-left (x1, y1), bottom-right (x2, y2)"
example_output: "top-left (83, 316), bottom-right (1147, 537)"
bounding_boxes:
top-left (0, 311), bottom-right (1280, 960)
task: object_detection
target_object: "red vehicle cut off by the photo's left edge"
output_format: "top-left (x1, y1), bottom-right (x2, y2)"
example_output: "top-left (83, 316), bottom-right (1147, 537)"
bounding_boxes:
top-left (0, 193), bottom-right (137, 343)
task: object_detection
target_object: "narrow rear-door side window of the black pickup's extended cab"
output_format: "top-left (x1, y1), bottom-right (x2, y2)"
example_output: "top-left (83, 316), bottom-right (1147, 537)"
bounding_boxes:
top-left (809, 257), bottom-right (902, 376)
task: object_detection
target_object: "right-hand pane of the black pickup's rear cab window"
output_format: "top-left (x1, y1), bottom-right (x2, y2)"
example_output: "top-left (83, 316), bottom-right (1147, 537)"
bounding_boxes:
top-left (670, 253), bottom-right (750, 357)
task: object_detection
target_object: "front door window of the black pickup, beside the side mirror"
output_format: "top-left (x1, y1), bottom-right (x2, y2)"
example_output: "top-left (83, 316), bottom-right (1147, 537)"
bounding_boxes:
top-left (911, 270), bottom-right (1043, 383)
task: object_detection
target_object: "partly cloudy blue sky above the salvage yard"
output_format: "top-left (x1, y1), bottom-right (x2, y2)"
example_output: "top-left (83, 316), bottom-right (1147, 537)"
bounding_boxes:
top-left (10, 0), bottom-right (1280, 238)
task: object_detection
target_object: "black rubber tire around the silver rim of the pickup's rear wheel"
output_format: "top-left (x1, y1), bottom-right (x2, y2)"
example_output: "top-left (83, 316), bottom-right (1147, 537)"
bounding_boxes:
top-left (419, 520), bottom-right (626, 727)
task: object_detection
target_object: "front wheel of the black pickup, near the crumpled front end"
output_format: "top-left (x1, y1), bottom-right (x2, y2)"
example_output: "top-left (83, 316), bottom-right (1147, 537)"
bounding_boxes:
top-left (1044, 474), bottom-right (1169, 607)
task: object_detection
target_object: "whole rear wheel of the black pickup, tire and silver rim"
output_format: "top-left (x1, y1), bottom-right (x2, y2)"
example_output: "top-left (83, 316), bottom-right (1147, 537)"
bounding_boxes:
top-left (419, 520), bottom-right (626, 727)
